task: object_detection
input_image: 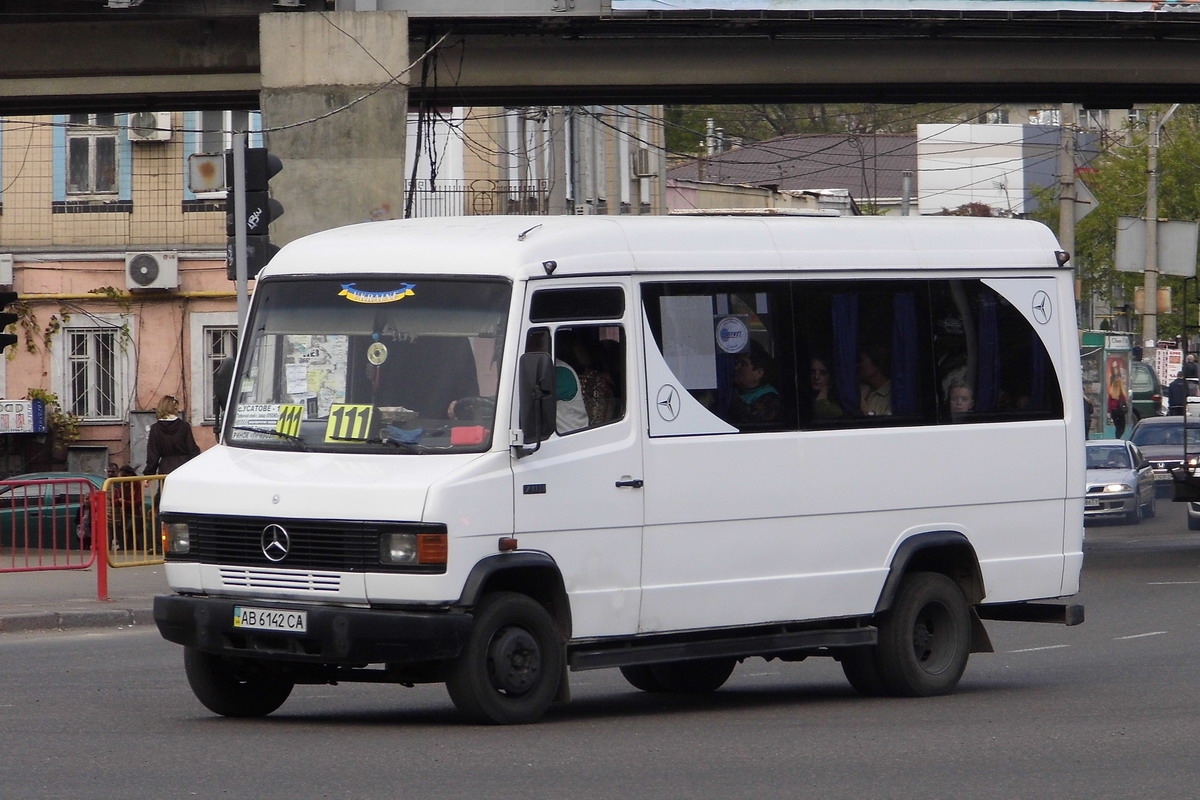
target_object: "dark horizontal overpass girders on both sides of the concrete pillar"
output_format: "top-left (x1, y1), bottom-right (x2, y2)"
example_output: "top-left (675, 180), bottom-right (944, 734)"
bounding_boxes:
top-left (7, 0), bottom-right (1200, 114)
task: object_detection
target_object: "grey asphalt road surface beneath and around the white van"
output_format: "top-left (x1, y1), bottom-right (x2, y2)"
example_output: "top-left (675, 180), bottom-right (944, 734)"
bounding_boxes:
top-left (0, 501), bottom-right (1200, 800)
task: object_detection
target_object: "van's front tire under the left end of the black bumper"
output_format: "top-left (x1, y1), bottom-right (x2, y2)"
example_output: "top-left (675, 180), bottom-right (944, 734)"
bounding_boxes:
top-left (184, 648), bottom-right (295, 717)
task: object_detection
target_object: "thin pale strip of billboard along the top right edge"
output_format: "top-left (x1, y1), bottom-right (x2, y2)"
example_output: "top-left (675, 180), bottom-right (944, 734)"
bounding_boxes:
top-left (610, 0), bottom-right (1200, 13)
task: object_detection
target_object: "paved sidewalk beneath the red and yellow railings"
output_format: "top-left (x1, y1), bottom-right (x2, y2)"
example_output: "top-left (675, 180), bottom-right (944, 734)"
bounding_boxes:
top-left (0, 564), bottom-right (170, 634)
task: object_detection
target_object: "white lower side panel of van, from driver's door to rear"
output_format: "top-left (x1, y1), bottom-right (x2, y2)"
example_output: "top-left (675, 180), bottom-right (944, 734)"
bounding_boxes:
top-left (641, 422), bottom-right (1064, 632)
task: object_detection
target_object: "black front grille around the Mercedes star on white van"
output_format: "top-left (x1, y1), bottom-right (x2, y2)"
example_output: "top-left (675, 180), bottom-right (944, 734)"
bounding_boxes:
top-left (163, 515), bottom-right (445, 572)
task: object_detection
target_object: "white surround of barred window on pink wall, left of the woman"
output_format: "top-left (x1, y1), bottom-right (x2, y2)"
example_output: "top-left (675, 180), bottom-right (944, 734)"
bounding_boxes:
top-left (52, 312), bottom-right (137, 423)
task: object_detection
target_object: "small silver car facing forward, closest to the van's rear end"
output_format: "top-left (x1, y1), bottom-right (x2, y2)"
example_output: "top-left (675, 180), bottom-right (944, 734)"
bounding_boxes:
top-left (1084, 439), bottom-right (1157, 523)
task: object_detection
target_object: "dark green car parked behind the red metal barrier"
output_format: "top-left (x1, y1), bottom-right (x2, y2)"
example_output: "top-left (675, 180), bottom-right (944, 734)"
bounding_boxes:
top-left (0, 473), bottom-right (104, 549)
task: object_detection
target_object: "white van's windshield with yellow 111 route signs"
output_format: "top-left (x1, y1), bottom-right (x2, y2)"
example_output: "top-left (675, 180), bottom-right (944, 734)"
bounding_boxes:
top-left (226, 276), bottom-right (511, 453)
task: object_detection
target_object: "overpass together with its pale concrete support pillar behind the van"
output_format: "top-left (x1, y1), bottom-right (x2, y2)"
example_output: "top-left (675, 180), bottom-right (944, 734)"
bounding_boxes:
top-left (0, 0), bottom-right (1200, 243)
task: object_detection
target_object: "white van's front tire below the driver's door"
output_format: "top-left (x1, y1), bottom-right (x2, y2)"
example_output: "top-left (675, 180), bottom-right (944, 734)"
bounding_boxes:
top-left (446, 591), bottom-right (565, 724)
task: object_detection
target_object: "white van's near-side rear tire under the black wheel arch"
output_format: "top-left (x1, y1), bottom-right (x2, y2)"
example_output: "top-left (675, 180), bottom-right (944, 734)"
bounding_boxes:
top-left (875, 572), bottom-right (971, 697)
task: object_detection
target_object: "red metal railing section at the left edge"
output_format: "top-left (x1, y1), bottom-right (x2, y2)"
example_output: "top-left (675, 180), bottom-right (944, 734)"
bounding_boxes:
top-left (0, 477), bottom-right (101, 572)
